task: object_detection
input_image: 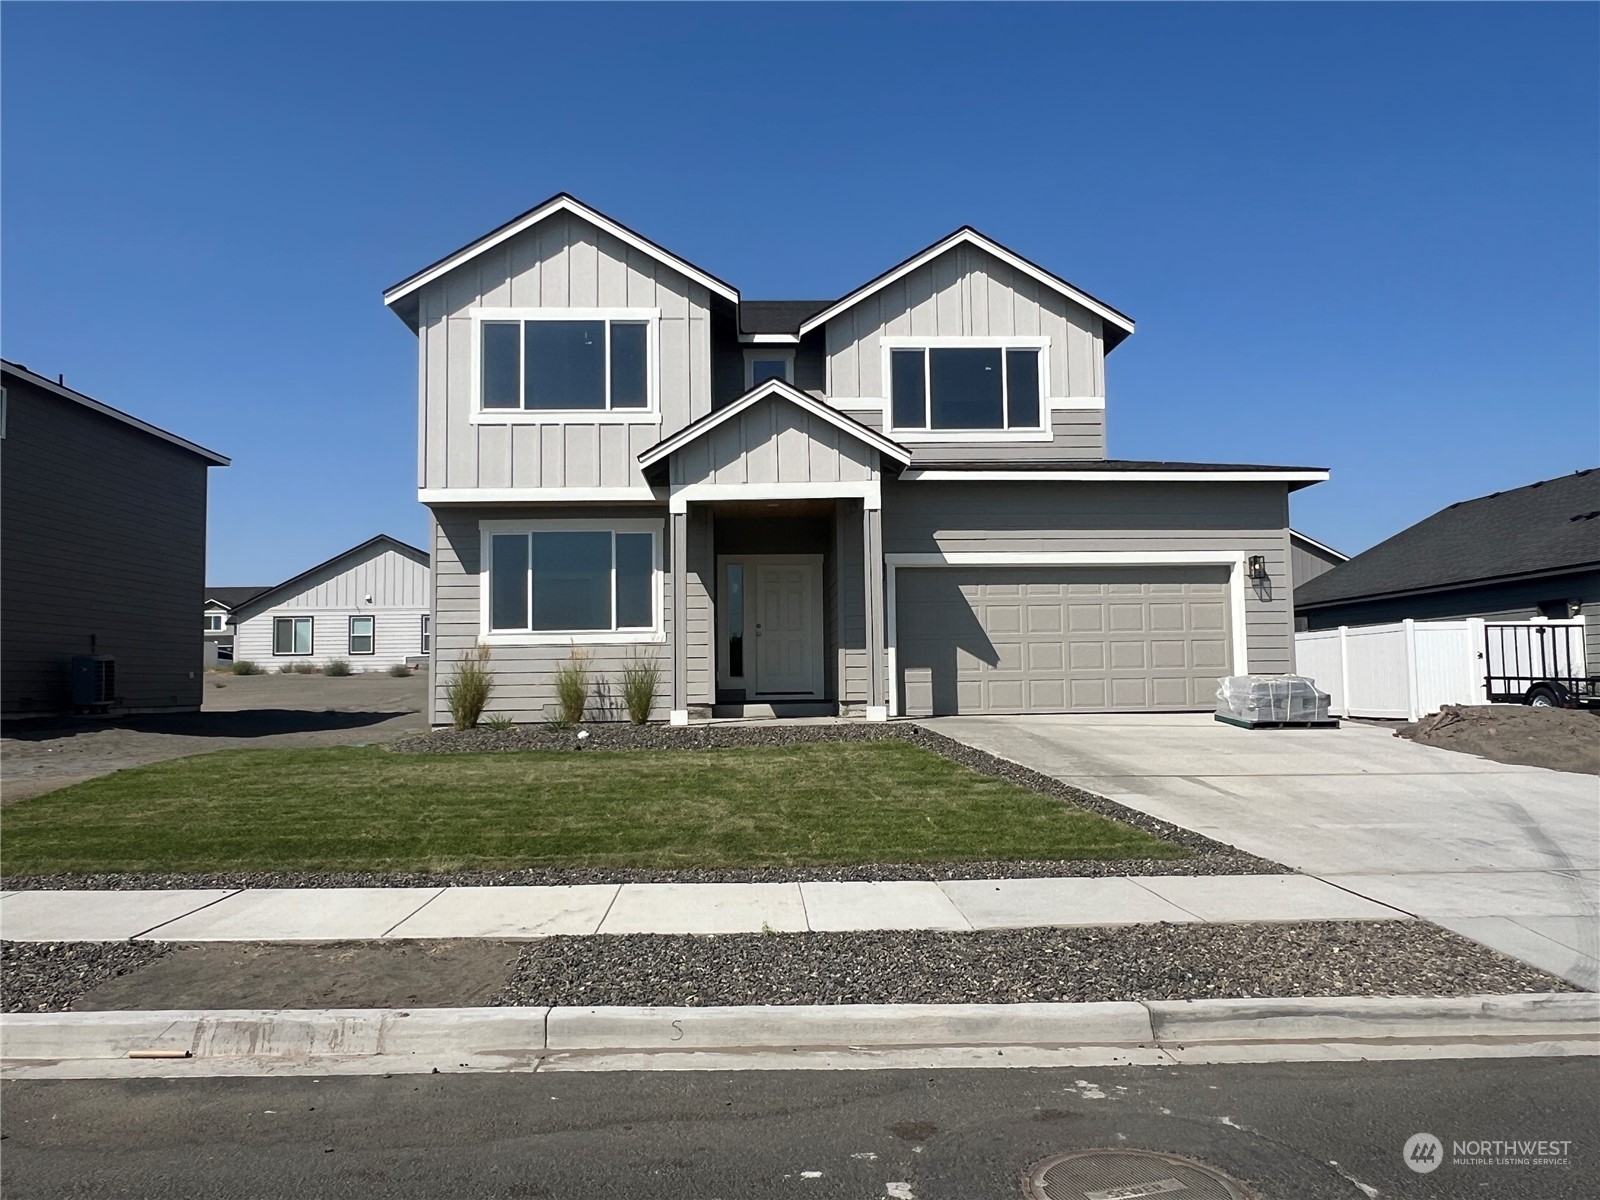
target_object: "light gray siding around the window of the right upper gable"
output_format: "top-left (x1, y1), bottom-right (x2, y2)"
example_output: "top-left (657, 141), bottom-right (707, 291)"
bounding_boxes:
top-left (824, 245), bottom-right (1106, 459)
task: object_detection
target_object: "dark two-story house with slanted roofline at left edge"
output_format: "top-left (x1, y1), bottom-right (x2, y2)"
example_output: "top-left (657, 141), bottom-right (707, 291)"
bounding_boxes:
top-left (0, 362), bottom-right (227, 715)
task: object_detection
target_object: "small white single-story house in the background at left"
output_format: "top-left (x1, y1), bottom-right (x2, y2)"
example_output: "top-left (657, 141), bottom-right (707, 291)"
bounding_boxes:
top-left (229, 533), bottom-right (430, 670)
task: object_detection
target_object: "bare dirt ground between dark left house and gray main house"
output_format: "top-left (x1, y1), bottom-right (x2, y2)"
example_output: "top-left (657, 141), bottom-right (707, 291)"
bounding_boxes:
top-left (0, 672), bottom-right (427, 803)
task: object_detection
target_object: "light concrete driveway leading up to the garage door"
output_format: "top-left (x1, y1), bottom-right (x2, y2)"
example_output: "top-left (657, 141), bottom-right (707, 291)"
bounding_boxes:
top-left (925, 714), bottom-right (1600, 990)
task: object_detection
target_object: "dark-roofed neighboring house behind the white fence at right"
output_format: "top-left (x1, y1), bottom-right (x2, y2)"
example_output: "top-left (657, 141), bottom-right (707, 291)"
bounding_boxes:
top-left (1294, 467), bottom-right (1600, 670)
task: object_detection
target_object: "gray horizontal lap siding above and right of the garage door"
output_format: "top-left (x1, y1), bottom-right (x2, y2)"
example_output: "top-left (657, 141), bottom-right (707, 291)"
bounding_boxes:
top-left (883, 483), bottom-right (1294, 674)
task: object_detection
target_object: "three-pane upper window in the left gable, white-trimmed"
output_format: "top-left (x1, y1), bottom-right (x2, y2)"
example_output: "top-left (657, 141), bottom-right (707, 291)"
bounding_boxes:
top-left (477, 309), bottom-right (656, 413)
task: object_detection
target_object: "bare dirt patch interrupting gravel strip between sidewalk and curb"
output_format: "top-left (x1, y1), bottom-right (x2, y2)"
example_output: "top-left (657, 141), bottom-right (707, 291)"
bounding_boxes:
top-left (72, 941), bottom-right (522, 1011)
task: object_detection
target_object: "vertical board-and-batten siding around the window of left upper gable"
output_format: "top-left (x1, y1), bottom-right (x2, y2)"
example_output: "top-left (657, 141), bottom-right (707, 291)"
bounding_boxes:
top-left (418, 213), bottom-right (712, 488)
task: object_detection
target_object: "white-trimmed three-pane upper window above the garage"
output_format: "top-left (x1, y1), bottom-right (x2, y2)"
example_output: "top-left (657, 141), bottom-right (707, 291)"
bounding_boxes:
top-left (888, 346), bottom-right (1045, 430)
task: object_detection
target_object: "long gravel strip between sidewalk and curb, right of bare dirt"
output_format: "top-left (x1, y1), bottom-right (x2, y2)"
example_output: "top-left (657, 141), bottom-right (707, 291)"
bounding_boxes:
top-left (494, 922), bottom-right (1579, 1006)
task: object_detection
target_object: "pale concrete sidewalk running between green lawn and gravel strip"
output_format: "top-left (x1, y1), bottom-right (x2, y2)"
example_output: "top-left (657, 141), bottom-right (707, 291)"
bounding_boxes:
top-left (0, 875), bottom-right (1408, 942)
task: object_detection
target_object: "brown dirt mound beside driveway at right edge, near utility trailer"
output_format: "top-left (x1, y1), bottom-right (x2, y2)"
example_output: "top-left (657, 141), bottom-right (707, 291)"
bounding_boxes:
top-left (1395, 704), bottom-right (1600, 774)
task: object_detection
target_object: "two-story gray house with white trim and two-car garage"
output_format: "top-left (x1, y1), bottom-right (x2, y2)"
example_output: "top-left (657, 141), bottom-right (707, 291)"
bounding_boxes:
top-left (384, 194), bottom-right (1326, 723)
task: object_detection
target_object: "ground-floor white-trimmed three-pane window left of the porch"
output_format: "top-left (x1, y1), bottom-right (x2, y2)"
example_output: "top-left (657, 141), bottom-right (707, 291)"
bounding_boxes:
top-left (485, 522), bottom-right (659, 635)
